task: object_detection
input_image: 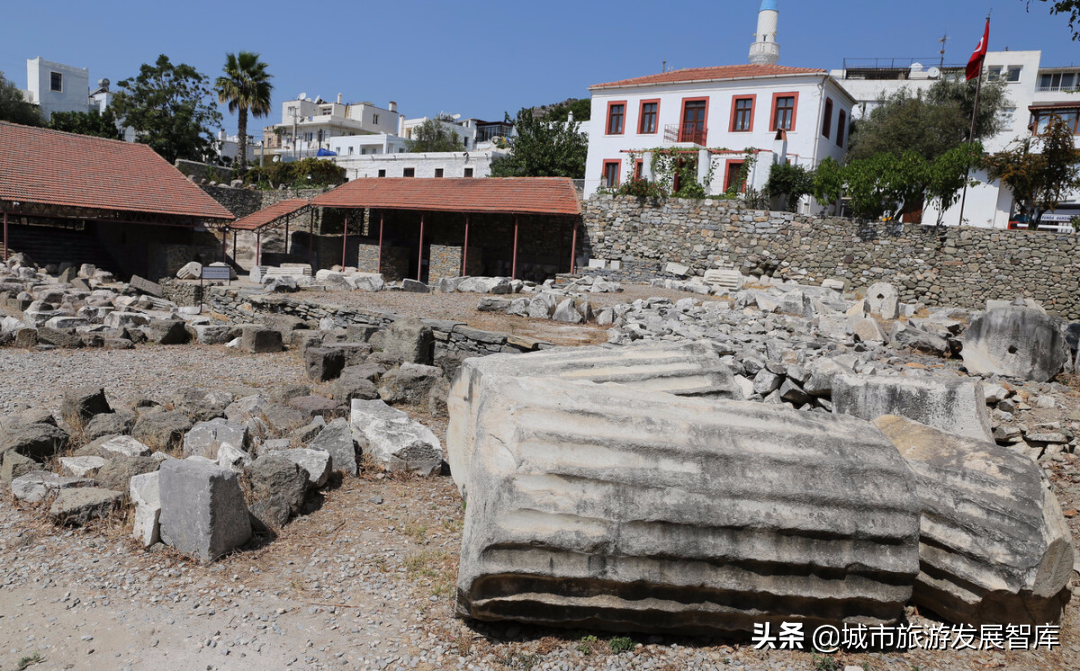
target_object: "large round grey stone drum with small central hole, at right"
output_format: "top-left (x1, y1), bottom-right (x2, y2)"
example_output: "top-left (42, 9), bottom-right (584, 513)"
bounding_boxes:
top-left (960, 306), bottom-right (1070, 383)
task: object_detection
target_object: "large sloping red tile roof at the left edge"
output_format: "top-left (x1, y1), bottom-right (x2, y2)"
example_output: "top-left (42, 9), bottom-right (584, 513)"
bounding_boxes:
top-left (0, 122), bottom-right (235, 220)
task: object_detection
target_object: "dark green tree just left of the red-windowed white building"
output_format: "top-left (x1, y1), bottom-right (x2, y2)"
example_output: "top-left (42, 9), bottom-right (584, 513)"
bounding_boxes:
top-left (491, 107), bottom-right (589, 179)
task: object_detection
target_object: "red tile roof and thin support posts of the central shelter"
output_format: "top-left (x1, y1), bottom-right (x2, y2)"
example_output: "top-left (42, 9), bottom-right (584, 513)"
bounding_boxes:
top-left (311, 177), bottom-right (581, 280)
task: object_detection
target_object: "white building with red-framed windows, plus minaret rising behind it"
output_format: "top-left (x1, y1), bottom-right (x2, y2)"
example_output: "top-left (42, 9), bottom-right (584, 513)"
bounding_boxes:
top-left (584, 0), bottom-right (855, 210)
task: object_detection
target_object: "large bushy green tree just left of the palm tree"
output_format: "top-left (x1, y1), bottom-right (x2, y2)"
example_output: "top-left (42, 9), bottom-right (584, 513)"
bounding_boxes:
top-left (112, 54), bottom-right (221, 163)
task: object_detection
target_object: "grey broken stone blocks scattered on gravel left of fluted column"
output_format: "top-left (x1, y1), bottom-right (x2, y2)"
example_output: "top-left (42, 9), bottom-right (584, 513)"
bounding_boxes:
top-left (0, 311), bottom-right (448, 562)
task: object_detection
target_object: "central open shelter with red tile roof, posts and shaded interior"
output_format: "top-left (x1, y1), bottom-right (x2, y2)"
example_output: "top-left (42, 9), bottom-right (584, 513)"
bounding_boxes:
top-left (311, 177), bottom-right (581, 282)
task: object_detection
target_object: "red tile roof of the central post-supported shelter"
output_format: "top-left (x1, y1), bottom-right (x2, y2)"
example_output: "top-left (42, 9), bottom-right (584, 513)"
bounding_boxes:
top-left (312, 177), bottom-right (581, 216)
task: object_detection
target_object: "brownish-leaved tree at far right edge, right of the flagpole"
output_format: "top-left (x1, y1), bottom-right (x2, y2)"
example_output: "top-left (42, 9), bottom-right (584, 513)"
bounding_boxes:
top-left (985, 117), bottom-right (1080, 229)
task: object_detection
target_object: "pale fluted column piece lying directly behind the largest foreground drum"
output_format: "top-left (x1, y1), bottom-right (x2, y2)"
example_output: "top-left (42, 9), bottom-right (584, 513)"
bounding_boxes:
top-left (446, 341), bottom-right (743, 496)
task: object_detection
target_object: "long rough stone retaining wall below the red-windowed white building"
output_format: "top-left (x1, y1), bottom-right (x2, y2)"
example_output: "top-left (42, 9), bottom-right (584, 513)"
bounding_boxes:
top-left (583, 196), bottom-right (1080, 320)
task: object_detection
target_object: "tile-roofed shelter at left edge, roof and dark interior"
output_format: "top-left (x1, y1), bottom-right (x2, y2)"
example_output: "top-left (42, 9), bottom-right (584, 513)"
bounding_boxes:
top-left (0, 122), bottom-right (234, 279)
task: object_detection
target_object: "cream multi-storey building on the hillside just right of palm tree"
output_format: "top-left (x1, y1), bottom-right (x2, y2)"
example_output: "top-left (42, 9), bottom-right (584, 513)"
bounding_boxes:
top-left (264, 93), bottom-right (404, 158)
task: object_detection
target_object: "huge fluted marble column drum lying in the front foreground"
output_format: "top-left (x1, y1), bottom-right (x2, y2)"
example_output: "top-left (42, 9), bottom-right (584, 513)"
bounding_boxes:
top-left (455, 377), bottom-right (919, 634)
